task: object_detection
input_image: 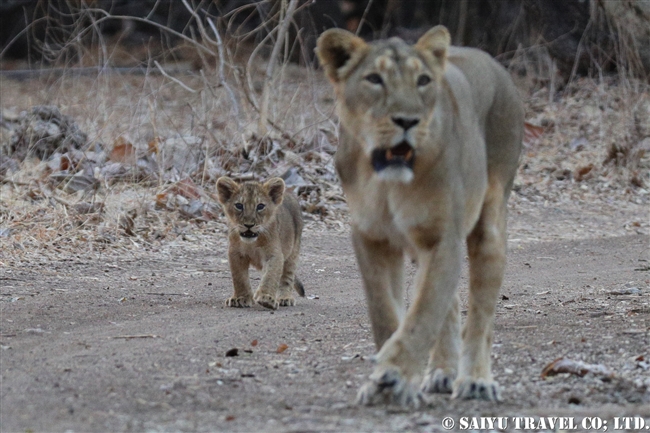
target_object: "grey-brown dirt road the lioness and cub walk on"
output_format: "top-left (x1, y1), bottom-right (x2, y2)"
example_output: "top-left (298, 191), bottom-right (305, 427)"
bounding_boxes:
top-left (0, 221), bottom-right (650, 432)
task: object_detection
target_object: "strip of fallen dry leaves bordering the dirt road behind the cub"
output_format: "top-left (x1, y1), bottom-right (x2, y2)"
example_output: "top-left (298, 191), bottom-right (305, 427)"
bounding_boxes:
top-left (0, 68), bottom-right (650, 258)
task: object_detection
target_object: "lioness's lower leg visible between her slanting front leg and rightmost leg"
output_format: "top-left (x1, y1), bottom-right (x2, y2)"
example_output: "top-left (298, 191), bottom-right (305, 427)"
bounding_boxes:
top-left (420, 294), bottom-right (461, 394)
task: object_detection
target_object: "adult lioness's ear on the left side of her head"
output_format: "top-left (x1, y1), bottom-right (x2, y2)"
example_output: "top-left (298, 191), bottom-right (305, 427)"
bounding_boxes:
top-left (316, 29), bottom-right (369, 83)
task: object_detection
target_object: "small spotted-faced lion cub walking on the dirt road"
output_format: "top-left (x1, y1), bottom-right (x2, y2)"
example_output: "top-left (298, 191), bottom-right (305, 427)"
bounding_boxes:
top-left (217, 177), bottom-right (305, 310)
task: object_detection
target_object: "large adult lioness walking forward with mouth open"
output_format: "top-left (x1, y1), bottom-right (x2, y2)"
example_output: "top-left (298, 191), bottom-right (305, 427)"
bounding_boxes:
top-left (317, 26), bottom-right (524, 407)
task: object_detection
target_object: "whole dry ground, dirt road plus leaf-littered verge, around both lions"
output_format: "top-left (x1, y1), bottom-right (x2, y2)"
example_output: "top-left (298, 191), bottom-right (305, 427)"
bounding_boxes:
top-left (0, 58), bottom-right (650, 432)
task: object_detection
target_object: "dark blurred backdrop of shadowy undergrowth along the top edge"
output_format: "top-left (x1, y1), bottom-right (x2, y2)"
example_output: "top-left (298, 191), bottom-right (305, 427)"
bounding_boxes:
top-left (0, 0), bottom-right (650, 81)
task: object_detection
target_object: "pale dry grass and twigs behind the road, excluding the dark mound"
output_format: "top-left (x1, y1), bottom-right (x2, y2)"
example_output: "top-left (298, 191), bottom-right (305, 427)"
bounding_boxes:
top-left (0, 4), bottom-right (650, 256)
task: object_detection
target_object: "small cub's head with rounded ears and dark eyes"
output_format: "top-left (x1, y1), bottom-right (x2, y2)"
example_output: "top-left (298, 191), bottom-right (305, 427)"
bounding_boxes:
top-left (217, 176), bottom-right (284, 243)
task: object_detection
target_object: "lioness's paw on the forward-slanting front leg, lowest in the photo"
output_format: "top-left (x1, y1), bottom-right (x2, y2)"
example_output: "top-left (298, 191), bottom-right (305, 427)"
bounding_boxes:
top-left (357, 367), bottom-right (424, 409)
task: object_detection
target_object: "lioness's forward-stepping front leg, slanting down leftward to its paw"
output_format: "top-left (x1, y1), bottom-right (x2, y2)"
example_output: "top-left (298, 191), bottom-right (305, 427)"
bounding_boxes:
top-left (358, 238), bottom-right (461, 407)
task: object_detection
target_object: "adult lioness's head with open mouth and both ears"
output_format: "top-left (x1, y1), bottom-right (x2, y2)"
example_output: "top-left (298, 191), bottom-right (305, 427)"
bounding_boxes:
top-left (316, 26), bottom-right (450, 183)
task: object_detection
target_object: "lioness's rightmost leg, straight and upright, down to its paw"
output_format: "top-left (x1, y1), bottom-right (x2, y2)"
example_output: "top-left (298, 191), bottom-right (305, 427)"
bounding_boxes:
top-left (453, 189), bottom-right (506, 401)
